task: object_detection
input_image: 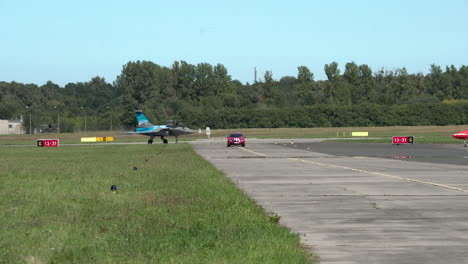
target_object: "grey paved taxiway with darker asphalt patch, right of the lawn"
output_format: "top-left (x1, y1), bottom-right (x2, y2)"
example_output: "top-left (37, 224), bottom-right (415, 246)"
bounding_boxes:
top-left (193, 140), bottom-right (468, 264)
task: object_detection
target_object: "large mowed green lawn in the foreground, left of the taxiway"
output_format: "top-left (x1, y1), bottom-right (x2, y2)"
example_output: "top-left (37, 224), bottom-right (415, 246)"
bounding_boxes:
top-left (0, 144), bottom-right (313, 263)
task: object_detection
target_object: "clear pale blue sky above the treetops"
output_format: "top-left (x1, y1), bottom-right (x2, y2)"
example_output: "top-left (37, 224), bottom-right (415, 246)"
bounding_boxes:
top-left (0, 0), bottom-right (468, 86)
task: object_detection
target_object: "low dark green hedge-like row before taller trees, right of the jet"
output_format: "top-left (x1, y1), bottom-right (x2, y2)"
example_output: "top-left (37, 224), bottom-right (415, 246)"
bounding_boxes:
top-left (187, 103), bottom-right (468, 128)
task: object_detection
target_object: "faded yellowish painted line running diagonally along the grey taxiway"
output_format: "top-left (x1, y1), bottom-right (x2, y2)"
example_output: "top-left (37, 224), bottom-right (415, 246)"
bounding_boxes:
top-left (241, 145), bottom-right (468, 193)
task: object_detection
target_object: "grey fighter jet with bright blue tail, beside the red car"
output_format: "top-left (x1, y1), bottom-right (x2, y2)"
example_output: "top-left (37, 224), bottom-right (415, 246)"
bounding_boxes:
top-left (120, 110), bottom-right (193, 144)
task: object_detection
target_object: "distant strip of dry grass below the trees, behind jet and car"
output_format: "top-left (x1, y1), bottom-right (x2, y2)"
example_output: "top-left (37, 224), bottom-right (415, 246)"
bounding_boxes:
top-left (0, 125), bottom-right (468, 145)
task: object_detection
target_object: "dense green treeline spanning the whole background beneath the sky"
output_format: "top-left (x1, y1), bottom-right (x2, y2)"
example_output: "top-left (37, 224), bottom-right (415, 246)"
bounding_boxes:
top-left (0, 61), bottom-right (468, 132)
